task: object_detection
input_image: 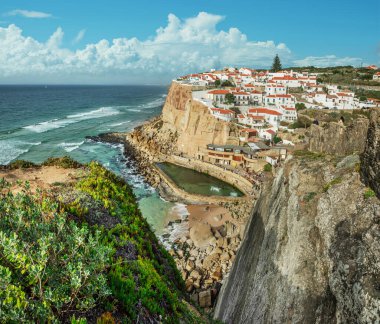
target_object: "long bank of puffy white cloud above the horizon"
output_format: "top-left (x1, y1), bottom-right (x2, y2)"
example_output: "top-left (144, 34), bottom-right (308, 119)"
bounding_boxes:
top-left (4, 12), bottom-right (360, 83)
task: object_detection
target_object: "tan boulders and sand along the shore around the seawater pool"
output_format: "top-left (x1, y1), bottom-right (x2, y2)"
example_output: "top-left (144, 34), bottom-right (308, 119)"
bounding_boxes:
top-left (91, 123), bottom-right (255, 310)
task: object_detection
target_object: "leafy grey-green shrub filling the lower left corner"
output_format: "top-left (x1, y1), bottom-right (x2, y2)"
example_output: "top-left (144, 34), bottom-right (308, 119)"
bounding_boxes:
top-left (0, 181), bottom-right (111, 322)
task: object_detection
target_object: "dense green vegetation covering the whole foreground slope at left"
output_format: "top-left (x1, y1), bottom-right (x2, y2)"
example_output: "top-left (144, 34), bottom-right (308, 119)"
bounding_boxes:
top-left (0, 160), bottom-right (199, 323)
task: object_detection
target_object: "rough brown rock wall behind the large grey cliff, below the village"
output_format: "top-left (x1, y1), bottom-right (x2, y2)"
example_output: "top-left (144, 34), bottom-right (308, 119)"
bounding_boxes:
top-left (306, 118), bottom-right (369, 155)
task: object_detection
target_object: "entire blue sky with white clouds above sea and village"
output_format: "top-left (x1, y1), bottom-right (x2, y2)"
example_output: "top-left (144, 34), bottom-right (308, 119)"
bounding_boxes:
top-left (0, 0), bottom-right (380, 84)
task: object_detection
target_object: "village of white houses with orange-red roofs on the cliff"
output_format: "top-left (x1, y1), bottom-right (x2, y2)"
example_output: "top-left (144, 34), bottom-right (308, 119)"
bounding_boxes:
top-left (173, 66), bottom-right (380, 172)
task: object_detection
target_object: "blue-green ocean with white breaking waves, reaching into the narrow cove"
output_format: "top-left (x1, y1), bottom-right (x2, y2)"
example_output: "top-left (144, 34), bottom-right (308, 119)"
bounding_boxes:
top-left (0, 86), bottom-right (186, 233)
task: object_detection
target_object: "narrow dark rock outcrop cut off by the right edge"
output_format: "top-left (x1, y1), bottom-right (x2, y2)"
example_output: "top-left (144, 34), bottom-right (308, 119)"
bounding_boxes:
top-left (361, 110), bottom-right (380, 198)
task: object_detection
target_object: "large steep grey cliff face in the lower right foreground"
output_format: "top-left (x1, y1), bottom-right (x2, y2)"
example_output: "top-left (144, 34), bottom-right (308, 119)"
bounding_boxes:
top-left (215, 153), bottom-right (380, 323)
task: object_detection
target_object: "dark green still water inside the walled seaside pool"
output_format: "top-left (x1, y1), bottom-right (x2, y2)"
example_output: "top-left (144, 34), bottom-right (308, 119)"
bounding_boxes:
top-left (157, 162), bottom-right (243, 197)
